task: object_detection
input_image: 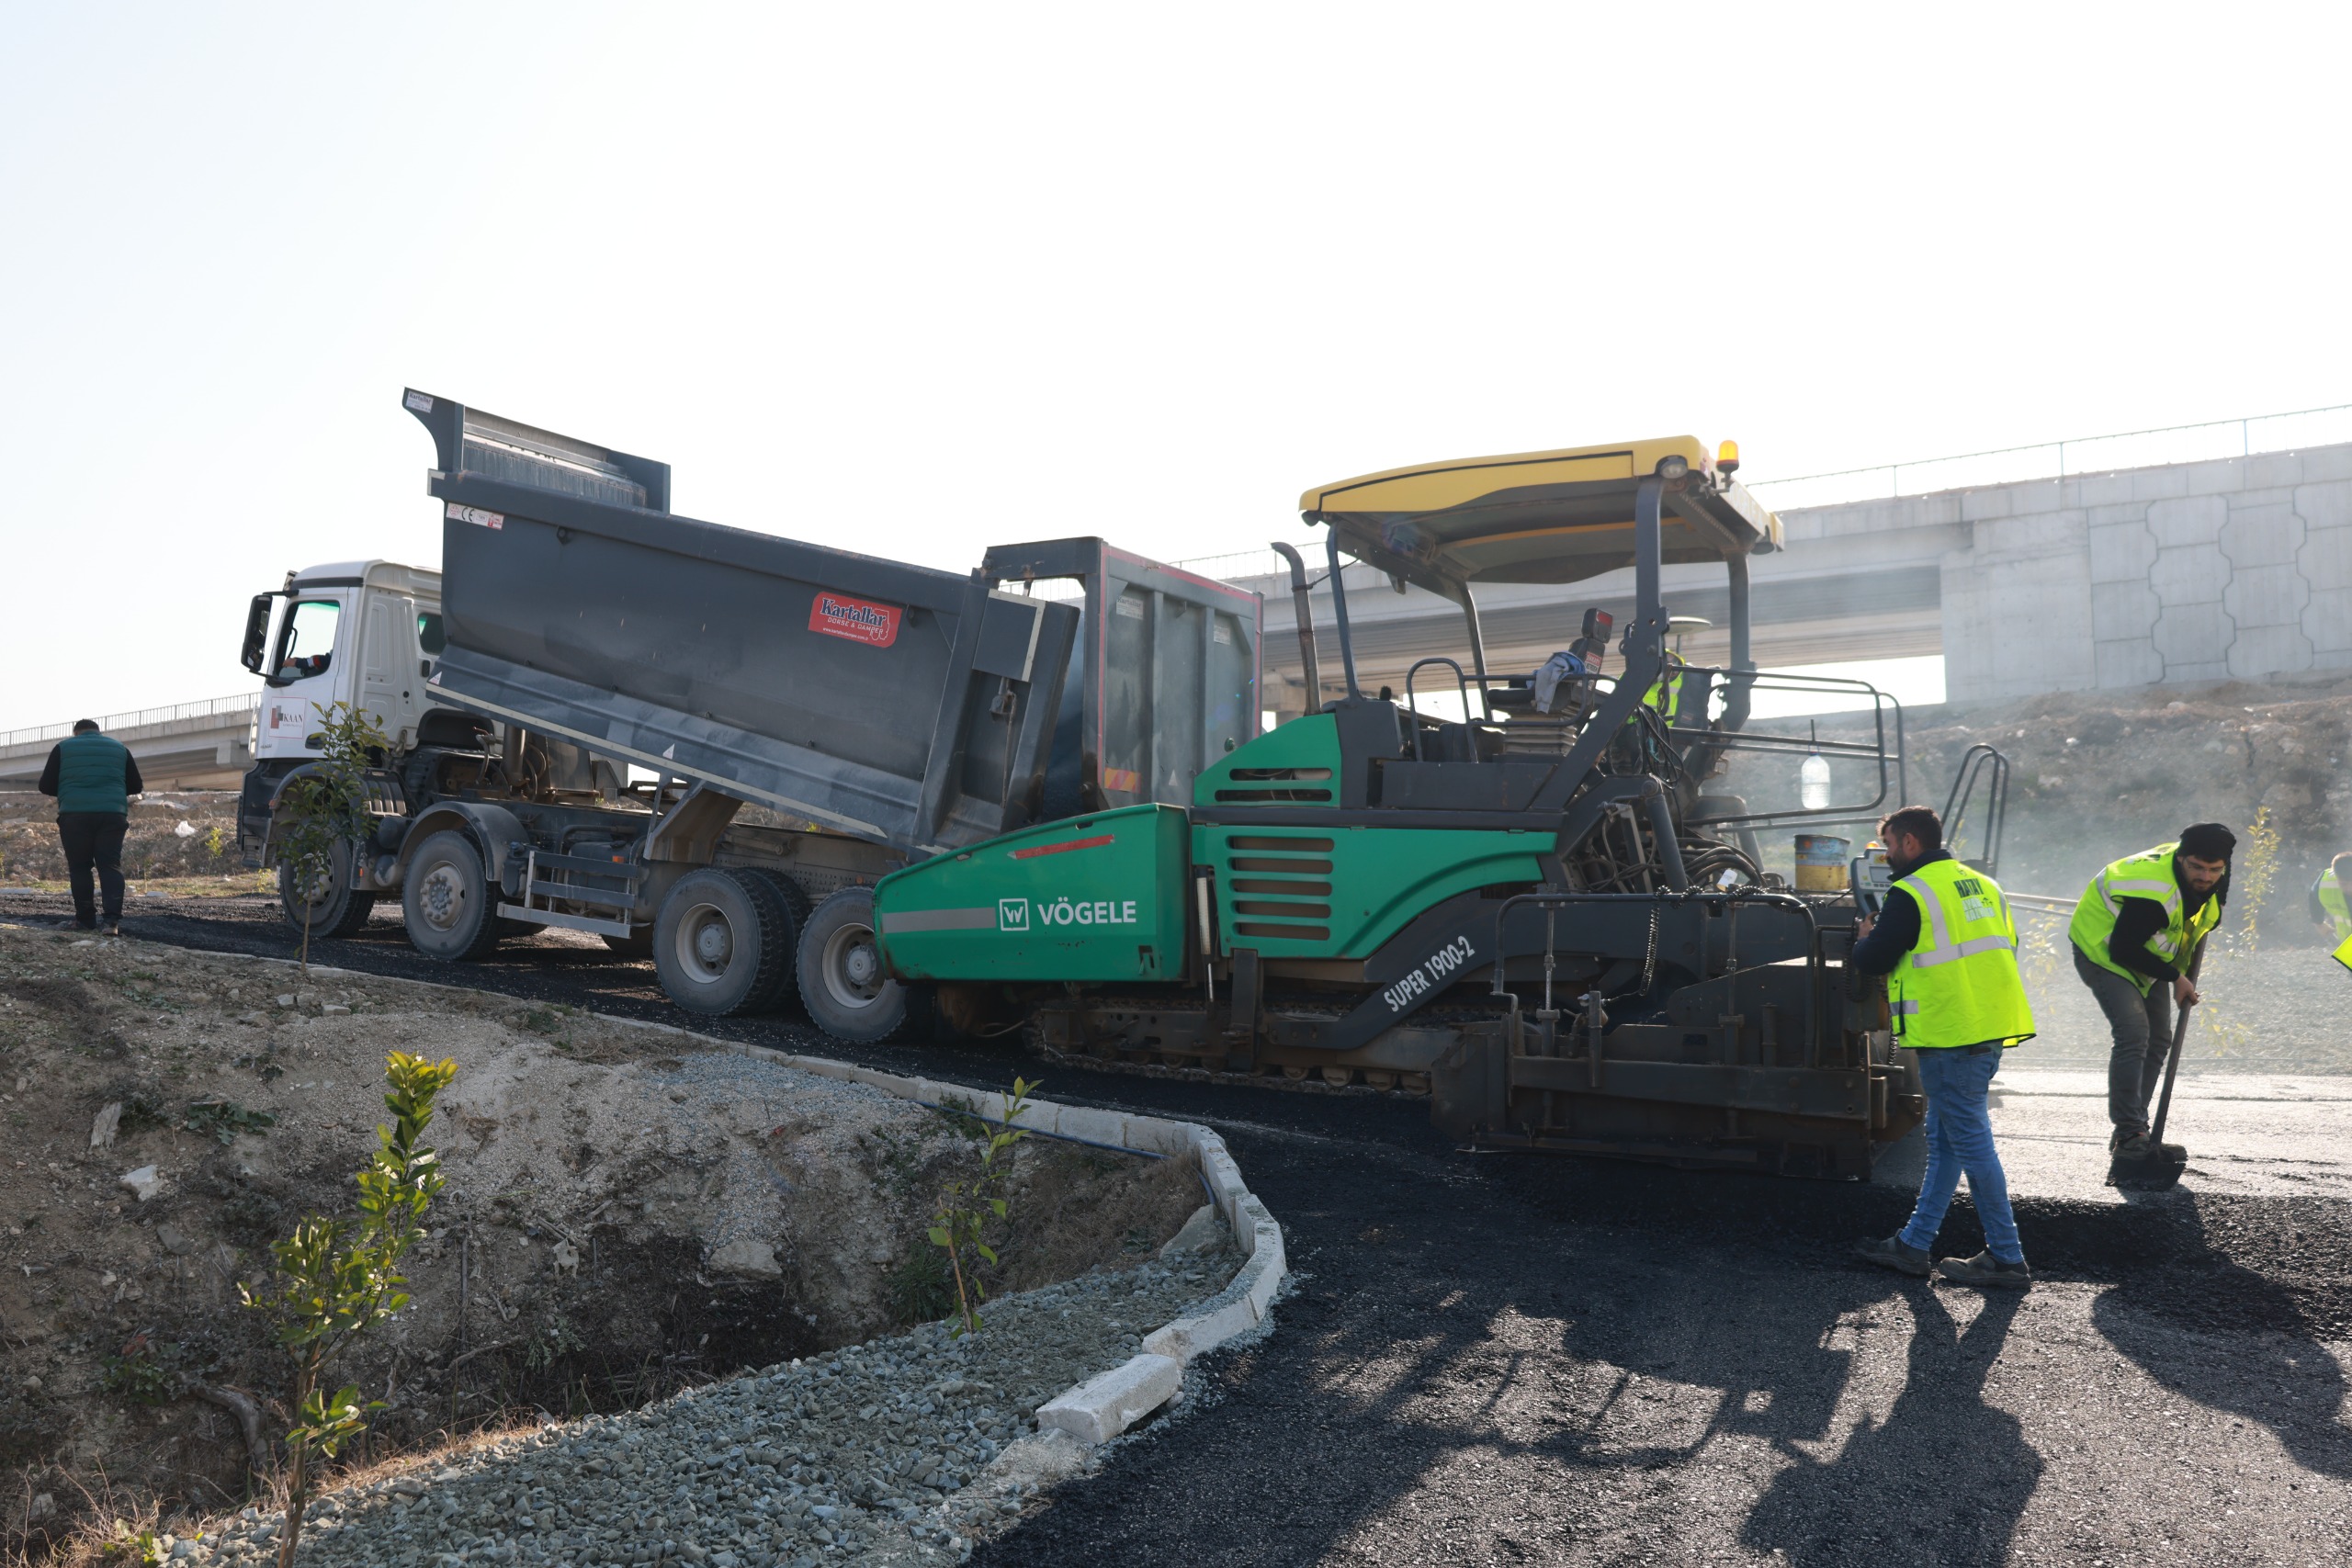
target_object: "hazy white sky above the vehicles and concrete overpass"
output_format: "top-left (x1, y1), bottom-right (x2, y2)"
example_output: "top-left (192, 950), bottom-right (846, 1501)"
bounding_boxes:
top-left (0, 0), bottom-right (2352, 727)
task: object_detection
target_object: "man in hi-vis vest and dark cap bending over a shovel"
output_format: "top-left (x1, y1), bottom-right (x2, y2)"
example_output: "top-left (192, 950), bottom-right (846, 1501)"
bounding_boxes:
top-left (2067, 823), bottom-right (2237, 1164)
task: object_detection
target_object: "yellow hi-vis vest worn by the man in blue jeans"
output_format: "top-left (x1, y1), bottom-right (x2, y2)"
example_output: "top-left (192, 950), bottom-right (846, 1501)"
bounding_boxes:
top-left (1886, 861), bottom-right (2034, 1051)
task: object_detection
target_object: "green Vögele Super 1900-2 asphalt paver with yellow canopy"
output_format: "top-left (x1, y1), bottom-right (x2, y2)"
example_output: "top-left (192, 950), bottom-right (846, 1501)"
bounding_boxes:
top-left (849, 437), bottom-right (1984, 1178)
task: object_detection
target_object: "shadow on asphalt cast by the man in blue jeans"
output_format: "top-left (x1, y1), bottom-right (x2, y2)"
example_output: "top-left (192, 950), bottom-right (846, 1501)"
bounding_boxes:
top-left (1740, 1283), bottom-right (2041, 1565)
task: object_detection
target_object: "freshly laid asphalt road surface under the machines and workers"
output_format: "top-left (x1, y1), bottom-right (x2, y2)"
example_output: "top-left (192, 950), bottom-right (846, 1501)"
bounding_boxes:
top-left (0, 894), bottom-right (2352, 1565)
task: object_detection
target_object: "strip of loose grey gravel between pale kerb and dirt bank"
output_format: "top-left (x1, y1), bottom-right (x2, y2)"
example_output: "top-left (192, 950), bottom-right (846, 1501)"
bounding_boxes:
top-left (176, 1248), bottom-right (1239, 1568)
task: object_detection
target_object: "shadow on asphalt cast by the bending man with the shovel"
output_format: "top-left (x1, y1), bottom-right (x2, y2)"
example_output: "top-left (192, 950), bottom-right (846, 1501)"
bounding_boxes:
top-left (2091, 1192), bottom-right (2352, 1479)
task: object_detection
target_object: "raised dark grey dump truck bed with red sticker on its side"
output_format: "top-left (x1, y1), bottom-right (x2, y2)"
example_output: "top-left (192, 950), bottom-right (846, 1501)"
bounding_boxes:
top-left (409, 392), bottom-right (1080, 853)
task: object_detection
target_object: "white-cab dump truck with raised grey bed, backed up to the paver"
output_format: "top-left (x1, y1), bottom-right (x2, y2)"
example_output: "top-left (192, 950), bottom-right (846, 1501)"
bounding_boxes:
top-left (238, 388), bottom-right (1259, 1039)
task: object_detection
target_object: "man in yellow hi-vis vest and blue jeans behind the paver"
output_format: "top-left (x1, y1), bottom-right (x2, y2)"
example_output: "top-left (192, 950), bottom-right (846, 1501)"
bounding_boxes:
top-left (1853, 807), bottom-right (2034, 1291)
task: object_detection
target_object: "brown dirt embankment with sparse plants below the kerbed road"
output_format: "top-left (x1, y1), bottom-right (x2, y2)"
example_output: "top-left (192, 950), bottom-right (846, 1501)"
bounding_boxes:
top-left (0, 926), bottom-right (1200, 1551)
